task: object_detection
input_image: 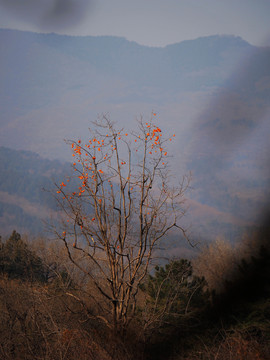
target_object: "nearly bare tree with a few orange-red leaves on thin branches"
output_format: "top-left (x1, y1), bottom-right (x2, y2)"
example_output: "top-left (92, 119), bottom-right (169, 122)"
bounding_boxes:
top-left (52, 114), bottom-right (189, 331)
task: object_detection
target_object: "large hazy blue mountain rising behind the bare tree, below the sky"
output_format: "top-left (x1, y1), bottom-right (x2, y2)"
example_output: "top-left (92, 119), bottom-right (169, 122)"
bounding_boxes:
top-left (0, 30), bottom-right (270, 237)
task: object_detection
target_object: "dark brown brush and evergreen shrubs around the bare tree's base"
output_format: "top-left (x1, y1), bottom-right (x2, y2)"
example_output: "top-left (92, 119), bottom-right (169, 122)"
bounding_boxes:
top-left (0, 228), bottom-right (270, 360)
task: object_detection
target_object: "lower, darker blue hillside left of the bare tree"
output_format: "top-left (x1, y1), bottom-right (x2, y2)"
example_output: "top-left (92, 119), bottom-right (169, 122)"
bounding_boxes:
top-left (0, 147), bottom-right (70, 235)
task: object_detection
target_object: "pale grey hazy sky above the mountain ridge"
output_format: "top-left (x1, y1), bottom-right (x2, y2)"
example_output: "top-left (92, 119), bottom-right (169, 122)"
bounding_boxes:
top-left (0, 0), bottom-right (270, 46)
